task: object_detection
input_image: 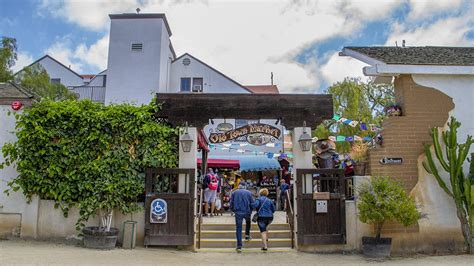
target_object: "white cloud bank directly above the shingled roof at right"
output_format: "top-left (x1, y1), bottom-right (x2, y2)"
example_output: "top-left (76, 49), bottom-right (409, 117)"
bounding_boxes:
top-left (385, 14), bottom-right (474, 46)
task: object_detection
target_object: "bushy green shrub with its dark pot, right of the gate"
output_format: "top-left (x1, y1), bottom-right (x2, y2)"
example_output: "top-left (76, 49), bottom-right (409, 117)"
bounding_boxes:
top-left (357, 177), bottom-right (421, 258)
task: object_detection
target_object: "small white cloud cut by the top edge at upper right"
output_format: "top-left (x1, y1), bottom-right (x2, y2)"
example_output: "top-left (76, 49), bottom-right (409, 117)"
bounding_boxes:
top-left (408, 0), bottom-right (463, 19)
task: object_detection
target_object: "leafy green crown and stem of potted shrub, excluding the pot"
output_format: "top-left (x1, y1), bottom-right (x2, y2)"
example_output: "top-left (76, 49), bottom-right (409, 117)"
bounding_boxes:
top-left (357, 177), bottom-right (421, 239)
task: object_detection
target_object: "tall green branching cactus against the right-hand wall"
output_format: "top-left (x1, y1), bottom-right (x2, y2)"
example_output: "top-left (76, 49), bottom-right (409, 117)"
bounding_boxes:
top-left (423, 117), bottom-right (474, 254)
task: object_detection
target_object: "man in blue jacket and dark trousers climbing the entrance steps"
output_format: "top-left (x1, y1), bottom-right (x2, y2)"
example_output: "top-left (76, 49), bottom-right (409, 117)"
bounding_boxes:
top-left (230, 182), bottom-right (254, 252)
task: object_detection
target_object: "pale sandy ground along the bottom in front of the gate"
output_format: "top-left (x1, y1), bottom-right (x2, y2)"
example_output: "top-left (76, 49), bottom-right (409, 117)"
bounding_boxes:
top-left (0, 240), bottom-right (474, 266)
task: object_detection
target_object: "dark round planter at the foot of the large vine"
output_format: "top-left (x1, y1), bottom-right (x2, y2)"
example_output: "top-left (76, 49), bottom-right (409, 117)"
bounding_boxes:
top-left (82, 226), bottom-right (118, 249)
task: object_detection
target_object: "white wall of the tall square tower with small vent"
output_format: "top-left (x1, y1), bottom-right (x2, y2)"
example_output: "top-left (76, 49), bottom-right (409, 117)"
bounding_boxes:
top-left (105, 18), bottom-right (169, 104)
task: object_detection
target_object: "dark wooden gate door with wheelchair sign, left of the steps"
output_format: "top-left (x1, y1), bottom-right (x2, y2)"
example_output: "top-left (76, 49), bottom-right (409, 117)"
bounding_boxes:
top-left (144, 168), bottom-right (196, 246)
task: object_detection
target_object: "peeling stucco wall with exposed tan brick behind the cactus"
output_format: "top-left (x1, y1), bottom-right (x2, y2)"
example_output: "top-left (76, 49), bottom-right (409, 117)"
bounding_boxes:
top-left (369, 75), bottom-right (466, 254)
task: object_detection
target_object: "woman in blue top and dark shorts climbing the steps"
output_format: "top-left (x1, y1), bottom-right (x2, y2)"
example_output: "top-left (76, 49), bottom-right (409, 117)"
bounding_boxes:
top-left (252, 188), bottom-right (275, 251)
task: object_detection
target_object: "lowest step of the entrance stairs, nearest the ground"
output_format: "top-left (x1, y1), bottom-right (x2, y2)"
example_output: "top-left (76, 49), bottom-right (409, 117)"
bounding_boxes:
top-left (201, 238), bottom-right (291, 248)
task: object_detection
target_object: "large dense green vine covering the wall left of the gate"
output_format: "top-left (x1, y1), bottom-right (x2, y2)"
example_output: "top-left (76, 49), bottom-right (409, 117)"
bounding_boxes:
top-left (1, 100), bottom-right (178, 229)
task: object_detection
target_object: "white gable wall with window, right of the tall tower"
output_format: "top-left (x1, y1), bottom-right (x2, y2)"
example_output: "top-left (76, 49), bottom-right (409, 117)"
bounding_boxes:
top-left (169, 55), bottom-right (250, 93)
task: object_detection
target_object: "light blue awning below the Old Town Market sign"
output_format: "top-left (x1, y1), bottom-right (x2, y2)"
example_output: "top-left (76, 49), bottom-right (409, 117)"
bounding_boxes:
top-left (208, 155), bottom-right (281, 172)
